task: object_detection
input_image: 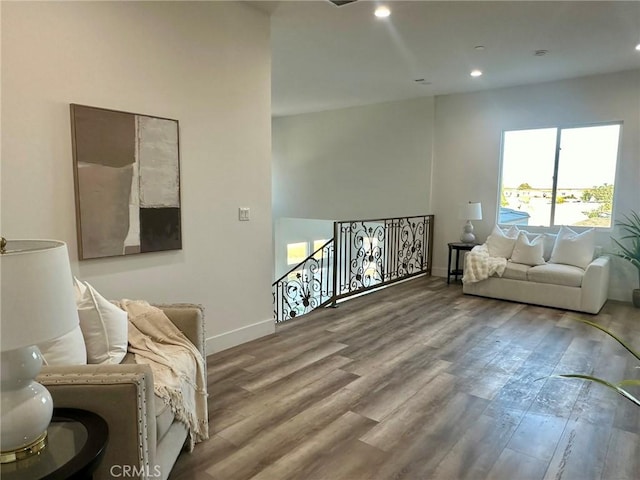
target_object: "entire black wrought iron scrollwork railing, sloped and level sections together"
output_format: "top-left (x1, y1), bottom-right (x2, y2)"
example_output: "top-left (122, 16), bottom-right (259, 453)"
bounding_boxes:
top-left (272, 215), bottom-right (434, 323)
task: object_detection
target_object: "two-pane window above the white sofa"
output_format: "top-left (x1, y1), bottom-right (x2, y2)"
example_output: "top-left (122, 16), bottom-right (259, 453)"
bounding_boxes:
top-left (498, 123), bottom-right (621, 228)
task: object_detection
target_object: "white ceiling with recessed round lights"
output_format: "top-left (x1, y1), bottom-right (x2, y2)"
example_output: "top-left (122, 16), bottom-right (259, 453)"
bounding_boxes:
top-left (264, 0), bottom-right (640, 116)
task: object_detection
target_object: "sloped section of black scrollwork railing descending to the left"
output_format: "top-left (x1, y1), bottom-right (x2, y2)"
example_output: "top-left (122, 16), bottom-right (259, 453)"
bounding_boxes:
top-left (273, 244), bottom-right (334, 323)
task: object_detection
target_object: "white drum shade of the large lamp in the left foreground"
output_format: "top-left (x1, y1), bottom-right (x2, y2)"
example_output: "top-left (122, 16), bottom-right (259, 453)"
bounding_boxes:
top-left (0, 240), bottom-right (79, 352)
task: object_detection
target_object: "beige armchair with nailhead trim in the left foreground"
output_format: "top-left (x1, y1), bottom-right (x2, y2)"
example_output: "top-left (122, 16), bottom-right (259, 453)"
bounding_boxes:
top-left (38, 304), bottom-right (206, 480)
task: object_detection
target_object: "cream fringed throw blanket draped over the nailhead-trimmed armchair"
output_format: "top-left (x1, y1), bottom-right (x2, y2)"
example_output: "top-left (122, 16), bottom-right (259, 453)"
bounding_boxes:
top-left (120, 300), bottom-right (209, 450)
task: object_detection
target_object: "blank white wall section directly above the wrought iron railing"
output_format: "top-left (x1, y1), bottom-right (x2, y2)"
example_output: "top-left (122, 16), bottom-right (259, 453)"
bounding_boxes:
top-left (273, 97), bottom-right (434, 220)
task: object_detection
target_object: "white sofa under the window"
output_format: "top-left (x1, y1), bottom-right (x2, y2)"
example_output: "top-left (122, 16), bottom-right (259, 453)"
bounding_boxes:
top-left (463, 226), bottom-right (610, 314)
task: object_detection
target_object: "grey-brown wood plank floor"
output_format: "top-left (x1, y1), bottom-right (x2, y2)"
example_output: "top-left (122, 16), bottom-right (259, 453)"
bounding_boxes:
top-left (170, 277), bottom-right (640, 480)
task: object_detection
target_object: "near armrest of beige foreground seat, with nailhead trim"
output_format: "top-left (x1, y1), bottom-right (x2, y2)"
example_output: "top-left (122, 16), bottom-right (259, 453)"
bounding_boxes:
top-left (37, 364), bottom-right (157, 480)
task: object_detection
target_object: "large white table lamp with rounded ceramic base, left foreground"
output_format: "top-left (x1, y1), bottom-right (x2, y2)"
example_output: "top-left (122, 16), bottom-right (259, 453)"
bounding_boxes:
top-left (0, 238), bottom-right (79, 463)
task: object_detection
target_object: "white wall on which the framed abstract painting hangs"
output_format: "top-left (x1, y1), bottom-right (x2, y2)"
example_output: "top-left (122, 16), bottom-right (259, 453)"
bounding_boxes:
top-left (1, 2), bottom-right (274, 351)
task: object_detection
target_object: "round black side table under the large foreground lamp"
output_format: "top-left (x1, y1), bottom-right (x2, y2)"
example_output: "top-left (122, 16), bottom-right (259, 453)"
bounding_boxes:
top-left (1, 408), bottom-right (109, 480)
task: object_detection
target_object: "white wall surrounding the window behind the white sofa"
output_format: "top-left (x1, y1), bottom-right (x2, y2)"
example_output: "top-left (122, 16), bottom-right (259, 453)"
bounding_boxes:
top-left (433, 70), bottom-right (640, 301)
